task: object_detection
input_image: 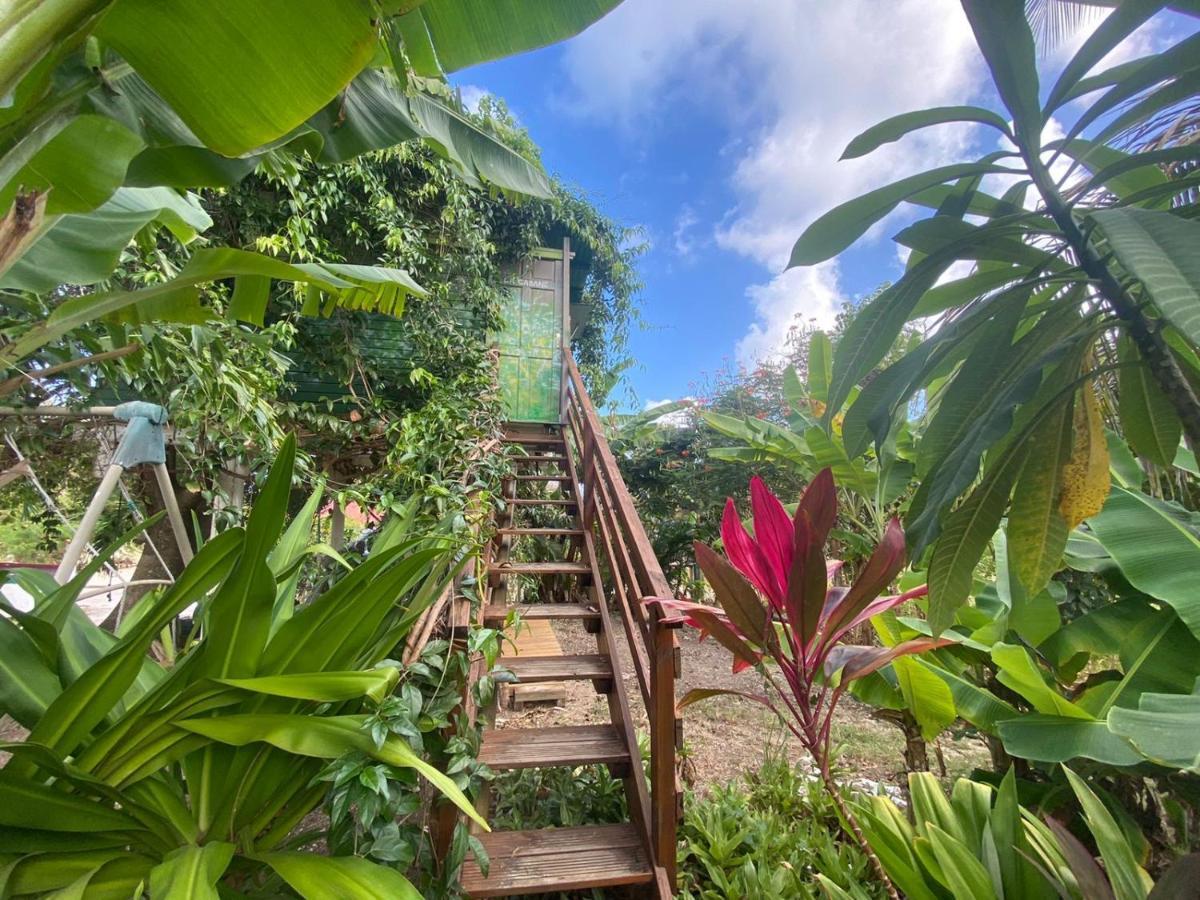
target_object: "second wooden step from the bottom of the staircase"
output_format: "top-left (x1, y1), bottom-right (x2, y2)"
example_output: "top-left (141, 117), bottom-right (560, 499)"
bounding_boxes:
top-left (479, 725), bottom-right (629, 772)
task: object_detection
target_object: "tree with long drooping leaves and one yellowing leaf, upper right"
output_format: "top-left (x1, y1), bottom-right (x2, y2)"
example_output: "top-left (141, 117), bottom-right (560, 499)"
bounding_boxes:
top-left (791, 0), bottom-right (1200, 634)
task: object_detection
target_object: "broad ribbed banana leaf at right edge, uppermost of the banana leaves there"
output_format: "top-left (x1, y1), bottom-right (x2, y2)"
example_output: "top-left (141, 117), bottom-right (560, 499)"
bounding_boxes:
top-left (1087, 485), bottom-right (1200, 637)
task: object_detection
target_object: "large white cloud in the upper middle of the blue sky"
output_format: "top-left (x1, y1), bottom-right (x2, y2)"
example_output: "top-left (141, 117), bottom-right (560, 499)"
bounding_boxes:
top-left (556, 0), bottom-right (984, 361)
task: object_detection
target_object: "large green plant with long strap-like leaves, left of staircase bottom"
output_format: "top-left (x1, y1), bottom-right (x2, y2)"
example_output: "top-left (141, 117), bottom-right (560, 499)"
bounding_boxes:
top-left (0, 438), bottom-right (486, 898)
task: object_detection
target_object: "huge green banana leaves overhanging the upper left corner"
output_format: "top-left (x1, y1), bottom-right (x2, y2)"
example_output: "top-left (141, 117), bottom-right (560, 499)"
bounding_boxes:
top-left (0, 0), bottom-right (616, 381)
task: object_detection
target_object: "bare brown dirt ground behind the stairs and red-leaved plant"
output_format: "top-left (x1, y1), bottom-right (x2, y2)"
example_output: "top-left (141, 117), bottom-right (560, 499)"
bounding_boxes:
top-left (496, 623), bottom-right (988, 790)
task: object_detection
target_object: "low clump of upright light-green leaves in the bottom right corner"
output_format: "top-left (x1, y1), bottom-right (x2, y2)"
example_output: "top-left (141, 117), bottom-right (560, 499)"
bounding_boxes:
top-left (862, 767), bottom-right (1198, 900)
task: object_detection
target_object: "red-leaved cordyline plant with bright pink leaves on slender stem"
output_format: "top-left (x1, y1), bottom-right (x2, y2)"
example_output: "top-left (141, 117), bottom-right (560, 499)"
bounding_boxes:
top-left (649, 469), bottom-right (949, 896)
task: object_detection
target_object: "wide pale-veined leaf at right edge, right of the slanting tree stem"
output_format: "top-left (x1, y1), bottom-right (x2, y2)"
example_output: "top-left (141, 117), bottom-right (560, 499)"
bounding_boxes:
top-left (1091, 208), bottom-right (1200, 346)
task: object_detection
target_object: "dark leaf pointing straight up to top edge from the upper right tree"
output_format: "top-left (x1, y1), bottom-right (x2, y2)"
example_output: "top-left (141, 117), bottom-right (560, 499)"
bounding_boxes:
top-left (962, 0), bottom-right (1043, 149)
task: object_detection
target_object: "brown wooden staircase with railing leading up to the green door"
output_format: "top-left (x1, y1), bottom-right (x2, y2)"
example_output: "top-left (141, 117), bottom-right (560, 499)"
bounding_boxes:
top-left (453, 359), bottom-right (680, 900)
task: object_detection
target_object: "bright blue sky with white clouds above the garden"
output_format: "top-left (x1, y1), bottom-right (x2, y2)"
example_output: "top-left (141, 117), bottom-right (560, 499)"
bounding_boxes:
top-left (455, 0), bottom-right (1190, 406)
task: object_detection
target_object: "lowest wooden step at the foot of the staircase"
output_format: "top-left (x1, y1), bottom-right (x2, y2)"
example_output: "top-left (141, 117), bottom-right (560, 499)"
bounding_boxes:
top-left (462, 823), bottom-right (654, 898)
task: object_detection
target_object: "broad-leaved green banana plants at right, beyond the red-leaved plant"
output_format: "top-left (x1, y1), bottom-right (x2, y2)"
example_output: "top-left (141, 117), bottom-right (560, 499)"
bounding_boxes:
top-left (886, 475), bottom-right (1200, 772)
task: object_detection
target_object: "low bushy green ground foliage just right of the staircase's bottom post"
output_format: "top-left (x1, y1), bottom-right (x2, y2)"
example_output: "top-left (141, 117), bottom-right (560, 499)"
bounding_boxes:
top-left (679, 755), bottom-right (884, 900)
